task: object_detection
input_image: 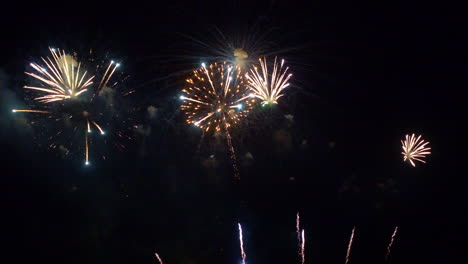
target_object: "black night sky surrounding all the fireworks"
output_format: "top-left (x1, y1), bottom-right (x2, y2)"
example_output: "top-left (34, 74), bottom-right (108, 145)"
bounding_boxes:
top-left (0, 1), bottom-right (468, 264)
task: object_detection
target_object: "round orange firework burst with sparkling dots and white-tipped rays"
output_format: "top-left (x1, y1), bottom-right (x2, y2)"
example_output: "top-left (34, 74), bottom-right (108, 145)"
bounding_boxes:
top-left (180, 62), bottom-right (255, 132)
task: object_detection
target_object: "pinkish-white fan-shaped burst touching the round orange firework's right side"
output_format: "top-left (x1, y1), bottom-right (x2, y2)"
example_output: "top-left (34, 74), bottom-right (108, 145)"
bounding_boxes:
top-left (246, 57), bottom-right (292, 105)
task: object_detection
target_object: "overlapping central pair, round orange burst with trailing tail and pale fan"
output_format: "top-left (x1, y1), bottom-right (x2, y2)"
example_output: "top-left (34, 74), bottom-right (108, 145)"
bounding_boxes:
top-left (180, 49), bottom-right (292, 177)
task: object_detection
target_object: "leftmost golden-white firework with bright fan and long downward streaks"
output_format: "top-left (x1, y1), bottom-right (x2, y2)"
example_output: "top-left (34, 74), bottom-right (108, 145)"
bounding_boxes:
top-left (12, 48), bottom-right (130, 165)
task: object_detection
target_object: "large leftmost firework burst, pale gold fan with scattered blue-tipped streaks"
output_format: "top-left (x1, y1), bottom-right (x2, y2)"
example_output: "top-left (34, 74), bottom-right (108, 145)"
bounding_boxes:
top-left (12, 48), bottom-right (133, 165)
